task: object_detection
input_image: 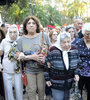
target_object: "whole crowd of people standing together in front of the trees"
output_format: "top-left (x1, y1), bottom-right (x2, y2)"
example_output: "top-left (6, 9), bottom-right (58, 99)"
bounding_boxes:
top-left (0, 16), bottom-right (90, 100)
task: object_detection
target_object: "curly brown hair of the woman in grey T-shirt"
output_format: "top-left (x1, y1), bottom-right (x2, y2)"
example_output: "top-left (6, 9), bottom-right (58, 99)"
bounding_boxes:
top-left (23, 16), bottom-right (40, 35)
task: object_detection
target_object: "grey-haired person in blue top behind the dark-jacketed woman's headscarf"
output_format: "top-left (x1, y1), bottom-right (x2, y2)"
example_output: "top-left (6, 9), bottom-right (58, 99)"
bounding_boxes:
top-left (65, 25), bottom-right (79, 44)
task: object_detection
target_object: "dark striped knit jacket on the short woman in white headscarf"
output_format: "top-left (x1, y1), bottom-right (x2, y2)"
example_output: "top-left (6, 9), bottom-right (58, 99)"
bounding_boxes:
top-left (44, 45), bottom-right (80, 90)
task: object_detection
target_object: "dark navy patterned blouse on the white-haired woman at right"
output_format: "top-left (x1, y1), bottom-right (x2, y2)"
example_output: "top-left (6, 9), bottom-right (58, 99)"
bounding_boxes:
top-left (76, 38), bottom-right (90, 77)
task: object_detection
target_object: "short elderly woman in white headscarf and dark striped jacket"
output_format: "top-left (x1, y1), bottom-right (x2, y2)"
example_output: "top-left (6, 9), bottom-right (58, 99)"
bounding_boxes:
top-left (45, 32), bottom-right (79, 100)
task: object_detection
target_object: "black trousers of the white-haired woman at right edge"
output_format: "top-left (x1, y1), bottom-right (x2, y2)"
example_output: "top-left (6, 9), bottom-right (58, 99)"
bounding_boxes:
top-left (79, 76), bottom-right (90, 100)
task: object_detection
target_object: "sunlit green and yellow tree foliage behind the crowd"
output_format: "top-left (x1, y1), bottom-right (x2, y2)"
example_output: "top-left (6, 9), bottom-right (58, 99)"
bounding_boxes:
top-left (0, 0), bottom-right (90, 26)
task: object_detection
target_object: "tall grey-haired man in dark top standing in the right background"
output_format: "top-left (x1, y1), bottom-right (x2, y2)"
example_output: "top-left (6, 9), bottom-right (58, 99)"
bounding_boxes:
top-left (74, 17), bottom-right (83, 38)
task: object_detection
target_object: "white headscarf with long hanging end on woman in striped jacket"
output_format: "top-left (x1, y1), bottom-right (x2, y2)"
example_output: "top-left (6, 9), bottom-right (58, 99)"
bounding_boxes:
top-left (54, 31), bottom-right (71, 70)
